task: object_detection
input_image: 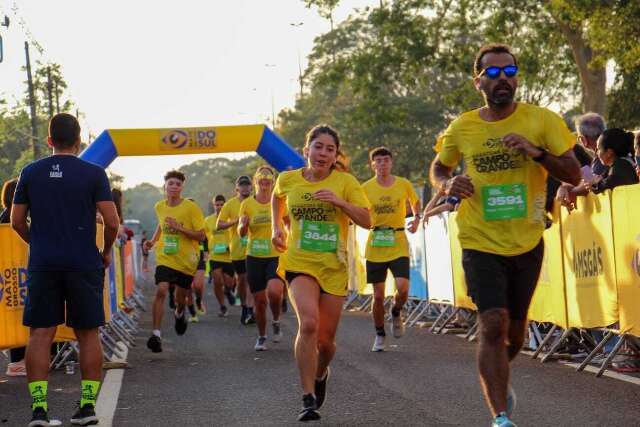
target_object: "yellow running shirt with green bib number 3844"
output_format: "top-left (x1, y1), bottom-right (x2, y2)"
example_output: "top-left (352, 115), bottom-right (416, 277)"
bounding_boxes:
top-left (274, 169), bottom-right (369, 296)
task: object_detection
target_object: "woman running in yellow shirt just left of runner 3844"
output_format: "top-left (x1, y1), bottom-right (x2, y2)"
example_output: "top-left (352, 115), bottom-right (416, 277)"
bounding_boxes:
top-left (238, 166), bottom-right (284, 351)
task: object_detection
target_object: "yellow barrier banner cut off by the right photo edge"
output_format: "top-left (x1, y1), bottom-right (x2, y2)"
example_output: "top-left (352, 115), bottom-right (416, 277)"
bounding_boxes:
top-left (611, 185), bottom-right (640, 336)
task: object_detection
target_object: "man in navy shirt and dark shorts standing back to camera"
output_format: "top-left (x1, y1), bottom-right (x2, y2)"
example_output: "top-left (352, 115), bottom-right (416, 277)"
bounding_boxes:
top-left (11, 113), bottom-right (119, 427)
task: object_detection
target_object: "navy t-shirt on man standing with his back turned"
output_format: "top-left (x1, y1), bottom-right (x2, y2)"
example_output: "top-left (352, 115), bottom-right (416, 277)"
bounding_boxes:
top-left (13, 155), bottom-right (112, 271)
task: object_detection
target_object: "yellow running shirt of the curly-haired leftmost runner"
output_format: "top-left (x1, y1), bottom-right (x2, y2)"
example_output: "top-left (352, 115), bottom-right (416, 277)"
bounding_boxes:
top-left (154, 199), bottom-right (204, 276)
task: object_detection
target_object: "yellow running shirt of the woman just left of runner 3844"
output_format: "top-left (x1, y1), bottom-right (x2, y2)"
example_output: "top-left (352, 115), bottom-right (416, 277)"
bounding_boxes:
top-left (239, 196), bottom-right (280, 258)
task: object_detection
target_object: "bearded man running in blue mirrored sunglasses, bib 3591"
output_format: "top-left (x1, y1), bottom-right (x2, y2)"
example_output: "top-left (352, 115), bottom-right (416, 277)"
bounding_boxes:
top-left (431, 44), bottom-right (580, 427)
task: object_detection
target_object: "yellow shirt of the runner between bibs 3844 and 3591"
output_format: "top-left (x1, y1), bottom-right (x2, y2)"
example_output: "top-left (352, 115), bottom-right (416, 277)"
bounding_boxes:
top-left (362, 176), bottom-right (418, 262)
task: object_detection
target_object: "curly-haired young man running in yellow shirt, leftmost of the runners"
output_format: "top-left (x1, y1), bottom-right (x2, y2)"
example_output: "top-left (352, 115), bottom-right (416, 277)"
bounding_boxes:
top-left (145, 171), bottom-right (205, 353)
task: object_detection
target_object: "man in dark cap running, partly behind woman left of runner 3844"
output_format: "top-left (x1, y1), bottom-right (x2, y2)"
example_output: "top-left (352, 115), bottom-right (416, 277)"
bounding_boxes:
top-left (217, 175), bottom-right (255, 325)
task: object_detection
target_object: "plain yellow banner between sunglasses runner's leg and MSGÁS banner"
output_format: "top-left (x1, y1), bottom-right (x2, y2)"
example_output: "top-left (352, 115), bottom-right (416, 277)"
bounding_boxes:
top-left (529, 204), bottom-right (567, 328)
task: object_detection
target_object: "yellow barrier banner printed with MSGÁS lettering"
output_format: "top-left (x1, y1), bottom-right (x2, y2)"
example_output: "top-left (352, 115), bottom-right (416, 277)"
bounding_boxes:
top-left (562, 192), bottom-right (618, 328)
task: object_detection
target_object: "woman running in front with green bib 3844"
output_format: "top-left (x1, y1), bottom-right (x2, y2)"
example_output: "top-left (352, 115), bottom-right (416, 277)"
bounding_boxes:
top-left (271, 125), bottom-right (371, 421)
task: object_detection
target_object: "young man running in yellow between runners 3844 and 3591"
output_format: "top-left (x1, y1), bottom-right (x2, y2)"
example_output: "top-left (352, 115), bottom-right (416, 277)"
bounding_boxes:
top-left (362, 147), bottom-right (421, 351)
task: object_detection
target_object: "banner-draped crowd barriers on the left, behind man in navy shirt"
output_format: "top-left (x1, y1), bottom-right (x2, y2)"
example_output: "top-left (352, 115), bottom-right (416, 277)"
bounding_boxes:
top-left (0, 224), bottom-right (144, 366)
